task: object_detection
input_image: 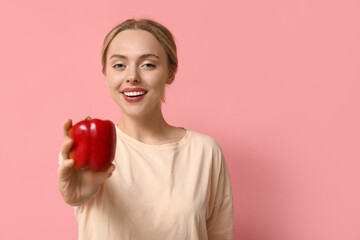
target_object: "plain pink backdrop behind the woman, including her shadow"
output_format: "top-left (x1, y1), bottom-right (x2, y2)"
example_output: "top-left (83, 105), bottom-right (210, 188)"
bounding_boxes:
top-left (0, 0), bottom-right (360, 240)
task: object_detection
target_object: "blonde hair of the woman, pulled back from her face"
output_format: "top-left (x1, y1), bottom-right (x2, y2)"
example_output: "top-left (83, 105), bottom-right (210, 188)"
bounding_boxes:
top-left (101, 18), bottom-right (178, 82)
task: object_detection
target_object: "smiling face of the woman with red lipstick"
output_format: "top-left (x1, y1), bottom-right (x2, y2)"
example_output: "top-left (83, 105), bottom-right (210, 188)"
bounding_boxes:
top-left (106, 30), bottom-right (171, 117)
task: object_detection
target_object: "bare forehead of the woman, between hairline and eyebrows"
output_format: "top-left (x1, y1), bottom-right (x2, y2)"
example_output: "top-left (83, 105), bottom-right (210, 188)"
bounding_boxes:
top-left (108, 29), bottom-right (166, 57)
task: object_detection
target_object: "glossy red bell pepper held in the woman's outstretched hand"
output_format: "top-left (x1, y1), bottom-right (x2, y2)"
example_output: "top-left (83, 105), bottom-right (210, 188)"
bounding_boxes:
top-left (68, 117), bottom-right (116, 172)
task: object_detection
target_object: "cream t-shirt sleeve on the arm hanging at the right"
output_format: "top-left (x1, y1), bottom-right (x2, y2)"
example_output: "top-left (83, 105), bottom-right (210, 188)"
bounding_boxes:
top-left (206, 149), bottom-right (234, 240)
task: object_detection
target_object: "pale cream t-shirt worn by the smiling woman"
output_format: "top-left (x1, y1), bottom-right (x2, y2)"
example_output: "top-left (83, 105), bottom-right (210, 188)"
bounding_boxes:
top-left (59, 127), bottom-right (233, 240)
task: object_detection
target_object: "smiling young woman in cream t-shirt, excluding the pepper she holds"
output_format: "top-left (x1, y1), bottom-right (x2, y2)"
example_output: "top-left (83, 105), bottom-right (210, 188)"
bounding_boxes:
top-left (58, 19), bottom-right (233, 240)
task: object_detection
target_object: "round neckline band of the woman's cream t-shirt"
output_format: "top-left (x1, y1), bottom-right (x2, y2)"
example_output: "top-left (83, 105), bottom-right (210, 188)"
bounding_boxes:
top-left (115, 125), bottom-right (192, 150)
